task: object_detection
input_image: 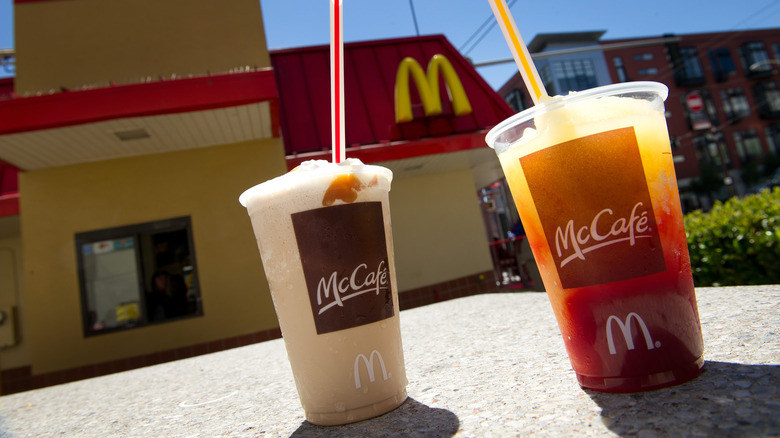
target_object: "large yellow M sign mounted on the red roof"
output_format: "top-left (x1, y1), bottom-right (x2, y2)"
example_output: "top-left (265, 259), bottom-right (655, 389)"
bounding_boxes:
top-left (395, 54), bottom-right (471, 123)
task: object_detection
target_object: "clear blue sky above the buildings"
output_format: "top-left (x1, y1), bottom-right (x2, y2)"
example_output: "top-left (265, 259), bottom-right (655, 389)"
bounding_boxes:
top-left (0, 0), bottom-right (780, 88)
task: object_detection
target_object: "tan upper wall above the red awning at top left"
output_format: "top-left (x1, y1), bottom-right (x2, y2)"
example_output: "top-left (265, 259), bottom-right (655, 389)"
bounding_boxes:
top-left (14, 0), bottom-right (271, 95)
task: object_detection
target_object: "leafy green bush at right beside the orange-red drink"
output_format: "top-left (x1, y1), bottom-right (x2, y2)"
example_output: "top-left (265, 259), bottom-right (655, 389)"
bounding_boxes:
top-left (685, 187), bottom-right (780, 286)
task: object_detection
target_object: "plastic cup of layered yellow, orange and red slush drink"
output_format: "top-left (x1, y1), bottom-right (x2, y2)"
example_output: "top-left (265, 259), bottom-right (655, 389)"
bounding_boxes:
top-left (487, 82), bottom-right (704, 392)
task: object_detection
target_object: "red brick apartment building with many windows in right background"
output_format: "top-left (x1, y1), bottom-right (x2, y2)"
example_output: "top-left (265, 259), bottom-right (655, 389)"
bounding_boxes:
top-left (499, 28), bottom-right (780, 211)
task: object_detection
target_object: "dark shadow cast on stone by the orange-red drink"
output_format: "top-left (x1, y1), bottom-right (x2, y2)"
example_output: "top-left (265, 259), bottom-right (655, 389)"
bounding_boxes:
top-left (585, 361), bottom-right (780, 437)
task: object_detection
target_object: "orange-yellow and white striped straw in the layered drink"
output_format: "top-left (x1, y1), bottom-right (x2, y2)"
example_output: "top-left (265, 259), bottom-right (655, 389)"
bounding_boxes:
top-left (488, 0), bottom-right (547, 105)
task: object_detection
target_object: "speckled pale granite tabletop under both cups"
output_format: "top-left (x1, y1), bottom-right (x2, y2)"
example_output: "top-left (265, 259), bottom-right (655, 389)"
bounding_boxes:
top-left (0, 286), bottom-right (780, 438)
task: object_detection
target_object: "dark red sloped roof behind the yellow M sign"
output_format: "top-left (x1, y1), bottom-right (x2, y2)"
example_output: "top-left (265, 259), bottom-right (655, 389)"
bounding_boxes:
top-left (271, 35), bottom-right (514, 167)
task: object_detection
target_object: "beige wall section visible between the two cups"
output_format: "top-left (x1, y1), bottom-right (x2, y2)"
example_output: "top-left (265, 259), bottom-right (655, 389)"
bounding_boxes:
top-left (390, 169), bottom-right (493, 291)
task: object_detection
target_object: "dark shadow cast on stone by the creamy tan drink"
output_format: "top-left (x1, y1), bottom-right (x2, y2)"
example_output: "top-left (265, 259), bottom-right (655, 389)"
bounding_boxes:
top-left (291, 397), bottom-right (460, 437)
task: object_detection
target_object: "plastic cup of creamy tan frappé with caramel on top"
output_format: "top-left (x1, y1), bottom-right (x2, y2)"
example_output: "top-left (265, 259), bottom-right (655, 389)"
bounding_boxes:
top-left (239, 159), bottom-right (407, 425)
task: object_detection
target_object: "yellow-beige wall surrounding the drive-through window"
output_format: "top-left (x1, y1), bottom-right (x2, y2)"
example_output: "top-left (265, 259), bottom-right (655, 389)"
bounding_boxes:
top-left (20, 139), bottom-right (286, 374)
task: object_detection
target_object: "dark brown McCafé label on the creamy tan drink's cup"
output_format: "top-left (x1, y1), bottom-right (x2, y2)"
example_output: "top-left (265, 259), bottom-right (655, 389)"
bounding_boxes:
top-left (292, 202), bottom-right (394, 334)
